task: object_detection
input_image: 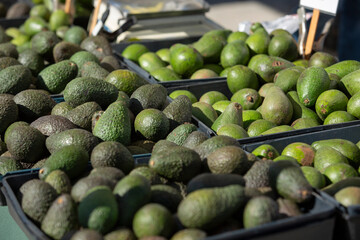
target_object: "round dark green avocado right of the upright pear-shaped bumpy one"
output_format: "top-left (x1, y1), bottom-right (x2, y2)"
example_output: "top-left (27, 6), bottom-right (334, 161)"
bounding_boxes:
top-left (134, 108), bottom-right (169, 141)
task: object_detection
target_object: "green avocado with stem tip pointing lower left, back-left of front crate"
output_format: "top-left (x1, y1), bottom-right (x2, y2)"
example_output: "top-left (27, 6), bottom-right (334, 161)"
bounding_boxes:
top-left (39, 146), bottom-right (89, 179)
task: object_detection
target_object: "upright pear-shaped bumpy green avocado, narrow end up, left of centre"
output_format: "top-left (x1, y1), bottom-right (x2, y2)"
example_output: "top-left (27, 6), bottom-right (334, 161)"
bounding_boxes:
top-left (93, 102), bottom-right (131, 145)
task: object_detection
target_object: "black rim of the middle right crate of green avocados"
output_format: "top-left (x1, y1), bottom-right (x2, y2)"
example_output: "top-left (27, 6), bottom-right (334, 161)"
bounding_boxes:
top-left (167, 80), bottom-right (360, 144)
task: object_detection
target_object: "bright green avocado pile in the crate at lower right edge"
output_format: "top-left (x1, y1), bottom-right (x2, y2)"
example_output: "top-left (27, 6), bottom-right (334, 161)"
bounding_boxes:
top-left (252, 138), bottom-right (360, 206)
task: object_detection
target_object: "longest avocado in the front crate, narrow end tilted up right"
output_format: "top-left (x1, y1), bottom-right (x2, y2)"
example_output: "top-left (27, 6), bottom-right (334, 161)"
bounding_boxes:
top-left (177, 185), bottom-right (246, 229)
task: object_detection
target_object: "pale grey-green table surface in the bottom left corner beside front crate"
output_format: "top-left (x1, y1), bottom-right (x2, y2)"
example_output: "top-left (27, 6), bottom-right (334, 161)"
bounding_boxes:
top-left (0, 206), bottom-right (28, 240)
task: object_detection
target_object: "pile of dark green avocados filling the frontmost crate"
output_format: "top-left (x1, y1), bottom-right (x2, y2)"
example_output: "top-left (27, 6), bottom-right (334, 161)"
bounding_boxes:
top-left (19, 135), bottom-right (315, 240)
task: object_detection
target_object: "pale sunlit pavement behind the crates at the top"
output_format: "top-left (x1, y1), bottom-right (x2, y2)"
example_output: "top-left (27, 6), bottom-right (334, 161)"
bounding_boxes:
top-left (206, 0), bottom-right (299, 31)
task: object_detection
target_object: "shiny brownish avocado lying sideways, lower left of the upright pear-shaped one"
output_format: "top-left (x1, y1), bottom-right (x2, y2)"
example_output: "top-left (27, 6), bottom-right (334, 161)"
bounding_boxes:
top-left (46, 128), bottom-right (99, 154)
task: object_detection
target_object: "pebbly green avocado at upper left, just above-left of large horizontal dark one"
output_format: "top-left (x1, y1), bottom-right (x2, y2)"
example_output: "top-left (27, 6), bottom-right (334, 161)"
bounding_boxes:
top-left (37, 60), bottom-right (78, 93)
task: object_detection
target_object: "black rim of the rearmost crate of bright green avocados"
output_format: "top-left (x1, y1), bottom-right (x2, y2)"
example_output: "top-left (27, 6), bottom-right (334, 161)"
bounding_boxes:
top-left (112, 37), bottom-right (226, 87)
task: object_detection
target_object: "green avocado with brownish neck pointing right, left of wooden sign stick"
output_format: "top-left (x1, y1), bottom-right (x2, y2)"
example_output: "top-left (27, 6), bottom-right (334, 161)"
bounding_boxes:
top-left (248, 54), bottom-right (294, 83)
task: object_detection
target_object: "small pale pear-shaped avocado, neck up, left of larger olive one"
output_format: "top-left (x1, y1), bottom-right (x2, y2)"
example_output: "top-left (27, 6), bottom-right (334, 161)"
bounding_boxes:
top-left (211, 102), bottom-right (243, 131)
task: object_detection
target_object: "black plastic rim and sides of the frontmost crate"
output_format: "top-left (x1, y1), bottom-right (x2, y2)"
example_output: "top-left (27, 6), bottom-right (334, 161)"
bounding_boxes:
top-left (2, 171), bottom-right (335, 240)
